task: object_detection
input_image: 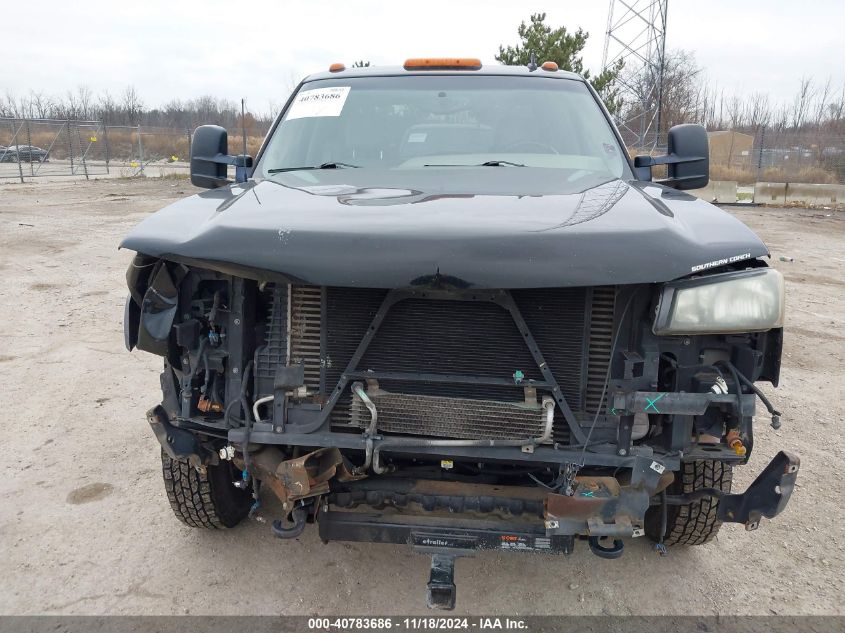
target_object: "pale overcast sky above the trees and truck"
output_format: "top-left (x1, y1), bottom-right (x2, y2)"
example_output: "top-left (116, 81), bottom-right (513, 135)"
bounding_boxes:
top-left (0, 0), bottom-right (845, 111)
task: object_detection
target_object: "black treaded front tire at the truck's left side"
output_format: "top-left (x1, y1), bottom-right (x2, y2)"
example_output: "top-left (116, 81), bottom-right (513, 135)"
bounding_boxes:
top-left (161, 450), bottom-right (252, 530)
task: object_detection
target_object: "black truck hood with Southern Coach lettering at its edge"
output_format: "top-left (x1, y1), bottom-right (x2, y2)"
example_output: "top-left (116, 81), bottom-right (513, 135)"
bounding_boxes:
top-left (121, 167), bottom-right (768, 288)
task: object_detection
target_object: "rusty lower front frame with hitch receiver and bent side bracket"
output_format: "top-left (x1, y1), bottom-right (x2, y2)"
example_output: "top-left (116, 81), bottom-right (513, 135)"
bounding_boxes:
top-left (219, 440), bottom-right (799, 609)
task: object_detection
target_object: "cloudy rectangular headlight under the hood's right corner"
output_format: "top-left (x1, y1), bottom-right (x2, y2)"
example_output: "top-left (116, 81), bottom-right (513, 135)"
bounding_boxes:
top-left (653, 268), bottom-right (784, 336)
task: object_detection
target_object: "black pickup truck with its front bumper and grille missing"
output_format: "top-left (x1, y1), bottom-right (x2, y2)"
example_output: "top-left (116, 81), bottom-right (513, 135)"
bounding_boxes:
top-left (122, 59), bottom-right (799, 608)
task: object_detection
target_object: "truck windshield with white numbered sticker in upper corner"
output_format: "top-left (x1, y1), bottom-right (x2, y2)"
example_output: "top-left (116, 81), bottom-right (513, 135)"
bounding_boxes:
top-left (256, 75), bottom-right (628, 178)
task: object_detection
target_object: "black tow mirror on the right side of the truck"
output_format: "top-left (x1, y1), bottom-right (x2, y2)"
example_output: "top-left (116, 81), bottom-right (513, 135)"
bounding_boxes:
top-left (634, 124), bottom-right (710, 189)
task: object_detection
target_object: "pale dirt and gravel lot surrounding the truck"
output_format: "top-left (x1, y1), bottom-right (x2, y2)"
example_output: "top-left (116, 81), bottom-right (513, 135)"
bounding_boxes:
top-left (0, 180), bottom-right (845, 615)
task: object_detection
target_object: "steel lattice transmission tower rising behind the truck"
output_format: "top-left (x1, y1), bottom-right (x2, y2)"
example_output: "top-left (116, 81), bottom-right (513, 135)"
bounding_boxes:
top-left (602, 0), bottom-right (669, 148)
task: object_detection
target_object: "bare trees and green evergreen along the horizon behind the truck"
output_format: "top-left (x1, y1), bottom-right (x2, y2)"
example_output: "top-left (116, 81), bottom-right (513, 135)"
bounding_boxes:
top-left (0, 53), bottom-right (845, 143)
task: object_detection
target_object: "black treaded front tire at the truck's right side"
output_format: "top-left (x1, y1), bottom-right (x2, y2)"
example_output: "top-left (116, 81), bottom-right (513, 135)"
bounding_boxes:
top-left (645, 460), bottom-right (733, 545)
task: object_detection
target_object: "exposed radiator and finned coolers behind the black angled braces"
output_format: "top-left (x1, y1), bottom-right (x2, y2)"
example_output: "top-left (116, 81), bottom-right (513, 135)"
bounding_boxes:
top-left (256, 285), bottom-right (615, 442)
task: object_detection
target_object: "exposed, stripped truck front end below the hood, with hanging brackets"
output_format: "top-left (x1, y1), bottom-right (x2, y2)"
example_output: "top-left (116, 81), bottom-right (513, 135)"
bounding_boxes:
top-left (126, 255), bottom-right (799, 608)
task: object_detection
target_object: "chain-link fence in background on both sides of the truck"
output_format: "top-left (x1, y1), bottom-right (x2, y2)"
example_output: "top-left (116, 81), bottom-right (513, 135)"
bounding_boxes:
top-left (6, 118), bottom-right (845, 184)
